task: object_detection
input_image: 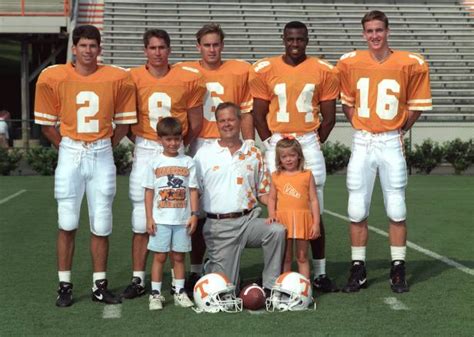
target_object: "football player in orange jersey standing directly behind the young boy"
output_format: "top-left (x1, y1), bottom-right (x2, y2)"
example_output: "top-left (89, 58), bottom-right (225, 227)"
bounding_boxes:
top-left (122, 29), bottom-right (206, 299)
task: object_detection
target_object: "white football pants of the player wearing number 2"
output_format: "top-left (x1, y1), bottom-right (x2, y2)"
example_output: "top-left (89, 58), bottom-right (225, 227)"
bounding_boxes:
top-left (54, 137), bottom-right (116, 236)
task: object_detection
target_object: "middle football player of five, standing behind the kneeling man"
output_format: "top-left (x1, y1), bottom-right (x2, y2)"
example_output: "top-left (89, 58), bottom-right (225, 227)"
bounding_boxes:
top-left (183, 23), bottom-right (255, 294)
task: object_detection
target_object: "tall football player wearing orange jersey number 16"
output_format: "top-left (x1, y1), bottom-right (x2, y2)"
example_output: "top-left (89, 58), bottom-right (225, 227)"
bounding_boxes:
top-left (337, 11), bottom-right (431, 293)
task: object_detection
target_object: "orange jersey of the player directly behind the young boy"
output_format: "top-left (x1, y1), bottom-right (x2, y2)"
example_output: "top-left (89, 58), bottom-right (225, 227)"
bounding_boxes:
top-left (131, 64), bottom-right (206, 140)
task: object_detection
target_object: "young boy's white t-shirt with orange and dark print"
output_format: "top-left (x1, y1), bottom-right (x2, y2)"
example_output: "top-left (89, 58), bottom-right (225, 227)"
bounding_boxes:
top-left (142, 154), bottom-right (198, 225)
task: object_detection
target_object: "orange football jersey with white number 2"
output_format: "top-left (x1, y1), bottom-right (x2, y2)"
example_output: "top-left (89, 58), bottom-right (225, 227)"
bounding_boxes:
top-left (35, 63), bottom-right (137, 142)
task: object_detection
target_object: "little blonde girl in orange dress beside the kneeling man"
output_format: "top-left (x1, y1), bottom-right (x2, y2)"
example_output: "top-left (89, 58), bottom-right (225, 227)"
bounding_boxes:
top-left (266, 137), bottom-right (320, 278)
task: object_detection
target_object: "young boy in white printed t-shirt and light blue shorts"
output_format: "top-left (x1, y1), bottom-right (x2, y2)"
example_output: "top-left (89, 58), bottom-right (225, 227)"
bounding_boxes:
top-left (142, 117), bottom-right (199, 310)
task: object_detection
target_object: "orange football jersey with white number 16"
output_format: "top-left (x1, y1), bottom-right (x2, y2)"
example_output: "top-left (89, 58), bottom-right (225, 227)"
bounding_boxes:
top-left (337, 50), bottom-right (432, 133)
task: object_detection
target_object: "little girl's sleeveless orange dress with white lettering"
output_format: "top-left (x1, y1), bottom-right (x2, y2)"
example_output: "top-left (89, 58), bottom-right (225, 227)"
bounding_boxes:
top-left (272, 170), bottom-right (313, 240)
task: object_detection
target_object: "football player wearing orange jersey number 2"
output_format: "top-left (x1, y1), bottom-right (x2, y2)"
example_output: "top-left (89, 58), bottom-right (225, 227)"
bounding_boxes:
top-left (35, 25), bottom-right (136, 307)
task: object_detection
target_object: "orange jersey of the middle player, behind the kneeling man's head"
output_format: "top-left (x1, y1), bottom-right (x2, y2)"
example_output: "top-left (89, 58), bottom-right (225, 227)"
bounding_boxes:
top-left (180, 60), bottom-right (252, 138)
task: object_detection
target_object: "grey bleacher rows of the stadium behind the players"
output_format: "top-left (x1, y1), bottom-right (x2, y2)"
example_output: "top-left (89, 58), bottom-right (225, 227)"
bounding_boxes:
top-left (103, 0), bottom-right (474, 120)
